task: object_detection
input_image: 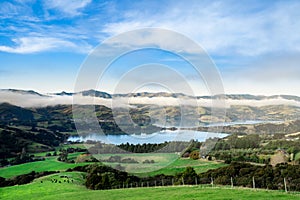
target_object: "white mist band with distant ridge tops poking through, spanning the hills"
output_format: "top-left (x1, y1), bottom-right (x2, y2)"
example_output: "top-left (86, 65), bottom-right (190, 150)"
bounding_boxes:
top-left (0, 89), bottom-right (300, 107)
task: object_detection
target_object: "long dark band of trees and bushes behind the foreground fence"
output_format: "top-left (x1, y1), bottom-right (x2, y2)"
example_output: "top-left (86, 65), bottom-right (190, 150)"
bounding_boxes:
top-left (69, 162), bottom-right (300, 191)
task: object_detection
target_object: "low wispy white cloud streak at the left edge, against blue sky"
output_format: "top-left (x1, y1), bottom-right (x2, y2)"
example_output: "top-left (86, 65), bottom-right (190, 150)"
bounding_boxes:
top-left (0, 37), bottom-right (90, 54)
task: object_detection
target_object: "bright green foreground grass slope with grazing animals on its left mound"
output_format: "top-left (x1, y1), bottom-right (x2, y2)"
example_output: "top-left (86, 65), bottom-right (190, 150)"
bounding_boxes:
top-left (0, 172), bottom-right (300, 200)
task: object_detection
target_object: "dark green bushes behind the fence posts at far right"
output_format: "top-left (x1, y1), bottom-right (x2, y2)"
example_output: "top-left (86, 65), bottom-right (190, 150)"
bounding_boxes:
top-left (199, 162), bottom-right (300, 191)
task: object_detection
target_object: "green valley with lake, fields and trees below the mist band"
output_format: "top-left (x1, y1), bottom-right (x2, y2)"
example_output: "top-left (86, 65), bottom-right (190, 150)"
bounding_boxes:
top-left (0, 91), bottom-right (300, 199)
